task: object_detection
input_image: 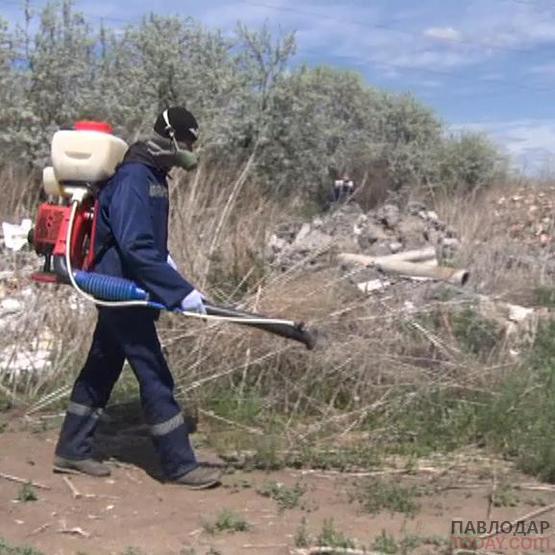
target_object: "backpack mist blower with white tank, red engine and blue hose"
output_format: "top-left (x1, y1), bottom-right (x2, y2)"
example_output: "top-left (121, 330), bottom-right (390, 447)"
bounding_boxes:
top-left (29, 121), bottom-right (315, 349)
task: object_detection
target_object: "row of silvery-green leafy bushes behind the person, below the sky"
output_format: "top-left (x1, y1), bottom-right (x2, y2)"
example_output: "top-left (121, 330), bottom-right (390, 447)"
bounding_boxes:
top-left (0, 0), bottom-right (499, 205)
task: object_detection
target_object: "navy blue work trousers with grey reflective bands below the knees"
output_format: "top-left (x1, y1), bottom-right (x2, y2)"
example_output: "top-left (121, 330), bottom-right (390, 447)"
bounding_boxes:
top-left (56, 307), bottom-right (198, 479)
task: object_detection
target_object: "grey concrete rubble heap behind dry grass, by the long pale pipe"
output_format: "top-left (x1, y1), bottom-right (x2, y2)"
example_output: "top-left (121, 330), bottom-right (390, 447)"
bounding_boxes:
top-left (268, 202), bottom-right (459, 278)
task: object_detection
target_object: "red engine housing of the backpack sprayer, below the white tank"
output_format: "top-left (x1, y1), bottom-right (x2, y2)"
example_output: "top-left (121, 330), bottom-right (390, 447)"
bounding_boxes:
top-left (31, 197), bottom-right (94, 283)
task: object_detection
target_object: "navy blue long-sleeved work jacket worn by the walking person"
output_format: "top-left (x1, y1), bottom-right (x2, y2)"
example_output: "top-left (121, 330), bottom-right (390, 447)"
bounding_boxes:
top-left (91, 162), bottom-right (193, 308)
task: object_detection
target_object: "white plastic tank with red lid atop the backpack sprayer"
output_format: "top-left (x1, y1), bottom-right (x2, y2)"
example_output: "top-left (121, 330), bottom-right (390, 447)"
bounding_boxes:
top-left (52, 122), bottom-right (128, 183)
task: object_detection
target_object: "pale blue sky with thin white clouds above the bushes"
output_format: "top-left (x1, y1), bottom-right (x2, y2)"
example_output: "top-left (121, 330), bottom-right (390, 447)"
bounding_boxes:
top-left (0, 0), bottom-right (555, 172)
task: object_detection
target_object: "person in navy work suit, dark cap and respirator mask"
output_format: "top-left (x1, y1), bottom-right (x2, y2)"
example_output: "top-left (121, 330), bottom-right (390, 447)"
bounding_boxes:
top-left (54, 106), bottom-right (221, 489)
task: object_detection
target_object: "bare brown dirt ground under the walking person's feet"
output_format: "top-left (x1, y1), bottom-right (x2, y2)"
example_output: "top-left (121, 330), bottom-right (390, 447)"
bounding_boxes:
top-left (0, 417), bottom-right (555, 555)
